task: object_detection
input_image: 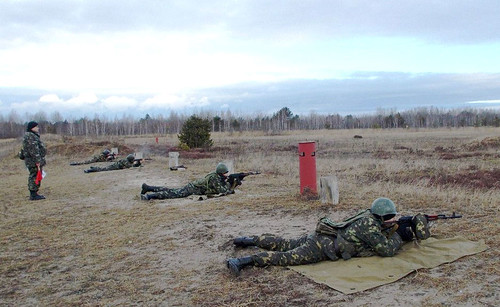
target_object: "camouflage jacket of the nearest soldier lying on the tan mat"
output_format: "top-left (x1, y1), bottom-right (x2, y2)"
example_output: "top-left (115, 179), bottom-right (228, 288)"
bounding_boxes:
top-left (337, 210), bottom-right (403, 259)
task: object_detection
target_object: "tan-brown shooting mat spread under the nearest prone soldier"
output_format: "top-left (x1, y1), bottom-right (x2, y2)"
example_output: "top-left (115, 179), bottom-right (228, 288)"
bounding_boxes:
top-left (288, 236), bottom-right (488, 294)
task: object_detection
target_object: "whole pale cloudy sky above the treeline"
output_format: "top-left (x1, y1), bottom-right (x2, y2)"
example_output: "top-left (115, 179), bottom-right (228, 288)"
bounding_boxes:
top-left (0, 0), bottom-right (500, 117)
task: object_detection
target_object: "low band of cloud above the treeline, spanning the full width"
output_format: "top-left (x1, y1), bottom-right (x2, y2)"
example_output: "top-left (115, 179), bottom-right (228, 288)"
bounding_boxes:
top-left (0, 72), bottom-right (500, 119)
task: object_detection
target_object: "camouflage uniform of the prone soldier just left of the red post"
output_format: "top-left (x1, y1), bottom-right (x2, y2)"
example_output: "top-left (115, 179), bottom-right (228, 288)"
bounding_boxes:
top-left (156, 172), bottom-right (231, 199)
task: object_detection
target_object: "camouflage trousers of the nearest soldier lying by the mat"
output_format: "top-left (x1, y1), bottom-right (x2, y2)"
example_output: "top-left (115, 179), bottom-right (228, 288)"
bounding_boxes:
top-left (252, 233), bottom-right (339, 266)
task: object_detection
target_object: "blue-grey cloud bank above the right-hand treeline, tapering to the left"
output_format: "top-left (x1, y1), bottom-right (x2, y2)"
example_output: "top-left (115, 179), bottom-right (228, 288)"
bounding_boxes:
top-left (185, 72), bottom-right (500, 114)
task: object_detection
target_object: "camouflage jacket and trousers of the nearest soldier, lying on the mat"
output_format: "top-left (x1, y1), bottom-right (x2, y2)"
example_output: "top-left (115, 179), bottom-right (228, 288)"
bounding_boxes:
top-left (251, 210), bottom-right (403, 266)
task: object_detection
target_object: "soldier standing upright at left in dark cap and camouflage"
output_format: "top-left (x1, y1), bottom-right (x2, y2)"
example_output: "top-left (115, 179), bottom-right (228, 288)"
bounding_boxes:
top-left (22, 121), bottom-right (47, 200)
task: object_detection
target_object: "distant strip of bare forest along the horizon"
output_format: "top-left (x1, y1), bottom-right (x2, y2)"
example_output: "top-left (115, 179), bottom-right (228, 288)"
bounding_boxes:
top-left (0, 107), bottom-right (500, 138)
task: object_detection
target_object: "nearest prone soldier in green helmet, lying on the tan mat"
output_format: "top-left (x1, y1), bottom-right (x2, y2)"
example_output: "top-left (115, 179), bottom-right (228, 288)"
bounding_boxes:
top-left (226, 198), bottom-right (430, 276)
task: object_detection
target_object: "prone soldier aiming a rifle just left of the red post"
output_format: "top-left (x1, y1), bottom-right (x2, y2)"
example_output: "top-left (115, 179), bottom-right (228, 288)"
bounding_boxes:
top-left (141, 163), bottom-right (234, 200)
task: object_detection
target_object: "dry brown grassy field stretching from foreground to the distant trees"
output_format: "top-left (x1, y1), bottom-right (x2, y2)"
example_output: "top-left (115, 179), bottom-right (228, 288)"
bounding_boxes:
top-left (0, 128), bottom-right (500, 306)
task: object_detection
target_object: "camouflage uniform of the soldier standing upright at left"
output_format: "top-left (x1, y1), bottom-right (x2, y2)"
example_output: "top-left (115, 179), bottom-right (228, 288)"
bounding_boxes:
top-left (23, 131), bottom-right (47, 192)
